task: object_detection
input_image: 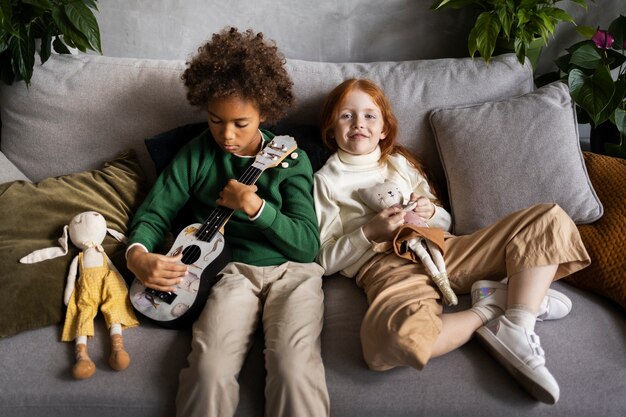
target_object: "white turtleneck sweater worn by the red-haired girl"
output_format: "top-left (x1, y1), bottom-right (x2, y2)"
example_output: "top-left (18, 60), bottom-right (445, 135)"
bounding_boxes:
top-left (314, 148), bottom-right (452, 277)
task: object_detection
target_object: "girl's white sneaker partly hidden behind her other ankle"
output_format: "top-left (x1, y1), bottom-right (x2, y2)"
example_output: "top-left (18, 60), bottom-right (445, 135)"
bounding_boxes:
top-left (472, 280), bottom-right (572, 321)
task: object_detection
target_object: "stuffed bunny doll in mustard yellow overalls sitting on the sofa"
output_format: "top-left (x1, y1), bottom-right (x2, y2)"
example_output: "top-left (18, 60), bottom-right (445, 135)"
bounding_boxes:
top-left (20, 211), bottom-right (139, 379)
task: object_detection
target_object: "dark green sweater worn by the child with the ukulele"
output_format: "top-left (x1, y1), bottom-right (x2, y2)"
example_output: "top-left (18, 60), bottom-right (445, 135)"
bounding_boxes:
top-left (129, 129), bottom-right (319, 266)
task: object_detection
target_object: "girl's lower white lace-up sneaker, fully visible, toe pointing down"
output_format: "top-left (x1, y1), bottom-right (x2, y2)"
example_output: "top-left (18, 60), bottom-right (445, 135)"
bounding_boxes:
top-left (476, 316), bottom-right (559, 404)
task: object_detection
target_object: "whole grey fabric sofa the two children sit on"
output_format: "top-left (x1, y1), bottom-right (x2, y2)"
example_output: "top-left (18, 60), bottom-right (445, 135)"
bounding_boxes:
top-left (0, 55), bottom-right (626, 417)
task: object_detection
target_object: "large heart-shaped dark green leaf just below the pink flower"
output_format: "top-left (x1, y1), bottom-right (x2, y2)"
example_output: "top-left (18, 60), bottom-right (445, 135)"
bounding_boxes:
top-left (567, 67), bottom-right (615, 126)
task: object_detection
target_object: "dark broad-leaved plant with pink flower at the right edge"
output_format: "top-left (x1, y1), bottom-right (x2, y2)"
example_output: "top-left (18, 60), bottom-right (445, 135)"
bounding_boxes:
top-left (537, 15), bottom-right (626, 157)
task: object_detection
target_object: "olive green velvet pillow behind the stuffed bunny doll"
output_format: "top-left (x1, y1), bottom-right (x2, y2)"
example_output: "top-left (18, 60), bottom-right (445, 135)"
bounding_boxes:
top-left (0, 151), bottom-right (145, 337)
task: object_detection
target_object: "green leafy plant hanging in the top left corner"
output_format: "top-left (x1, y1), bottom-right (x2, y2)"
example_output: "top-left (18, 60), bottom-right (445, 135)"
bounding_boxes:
top-left (0, 0), bottom-right (102, 85)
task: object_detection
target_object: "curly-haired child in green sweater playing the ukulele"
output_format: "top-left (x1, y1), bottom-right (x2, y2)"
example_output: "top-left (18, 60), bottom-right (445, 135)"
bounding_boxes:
top-left (127, 28), bottom-right (329, 417)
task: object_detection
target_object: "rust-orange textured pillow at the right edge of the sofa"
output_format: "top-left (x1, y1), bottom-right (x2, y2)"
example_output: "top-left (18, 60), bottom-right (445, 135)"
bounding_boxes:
top-left (565, 152), bottom-right (626, 308)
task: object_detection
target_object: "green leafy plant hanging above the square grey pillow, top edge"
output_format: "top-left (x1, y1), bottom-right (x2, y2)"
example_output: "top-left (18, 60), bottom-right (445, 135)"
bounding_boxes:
top-left (431, 0), bottom-right (594, 69)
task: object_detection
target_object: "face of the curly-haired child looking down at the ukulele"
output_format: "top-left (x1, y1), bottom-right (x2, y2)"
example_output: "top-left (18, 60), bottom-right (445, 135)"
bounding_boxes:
top-left (208, 97), bottom-right (265, 156)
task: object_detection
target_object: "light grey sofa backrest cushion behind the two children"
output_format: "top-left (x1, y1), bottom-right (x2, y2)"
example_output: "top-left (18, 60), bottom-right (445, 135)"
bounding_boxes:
top-left (0, 55), bottom-right (533, 184)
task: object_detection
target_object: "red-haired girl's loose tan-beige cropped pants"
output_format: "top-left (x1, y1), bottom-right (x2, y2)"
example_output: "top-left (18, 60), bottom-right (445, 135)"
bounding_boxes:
top-left (357, 204), bottom-right (590, 371)
